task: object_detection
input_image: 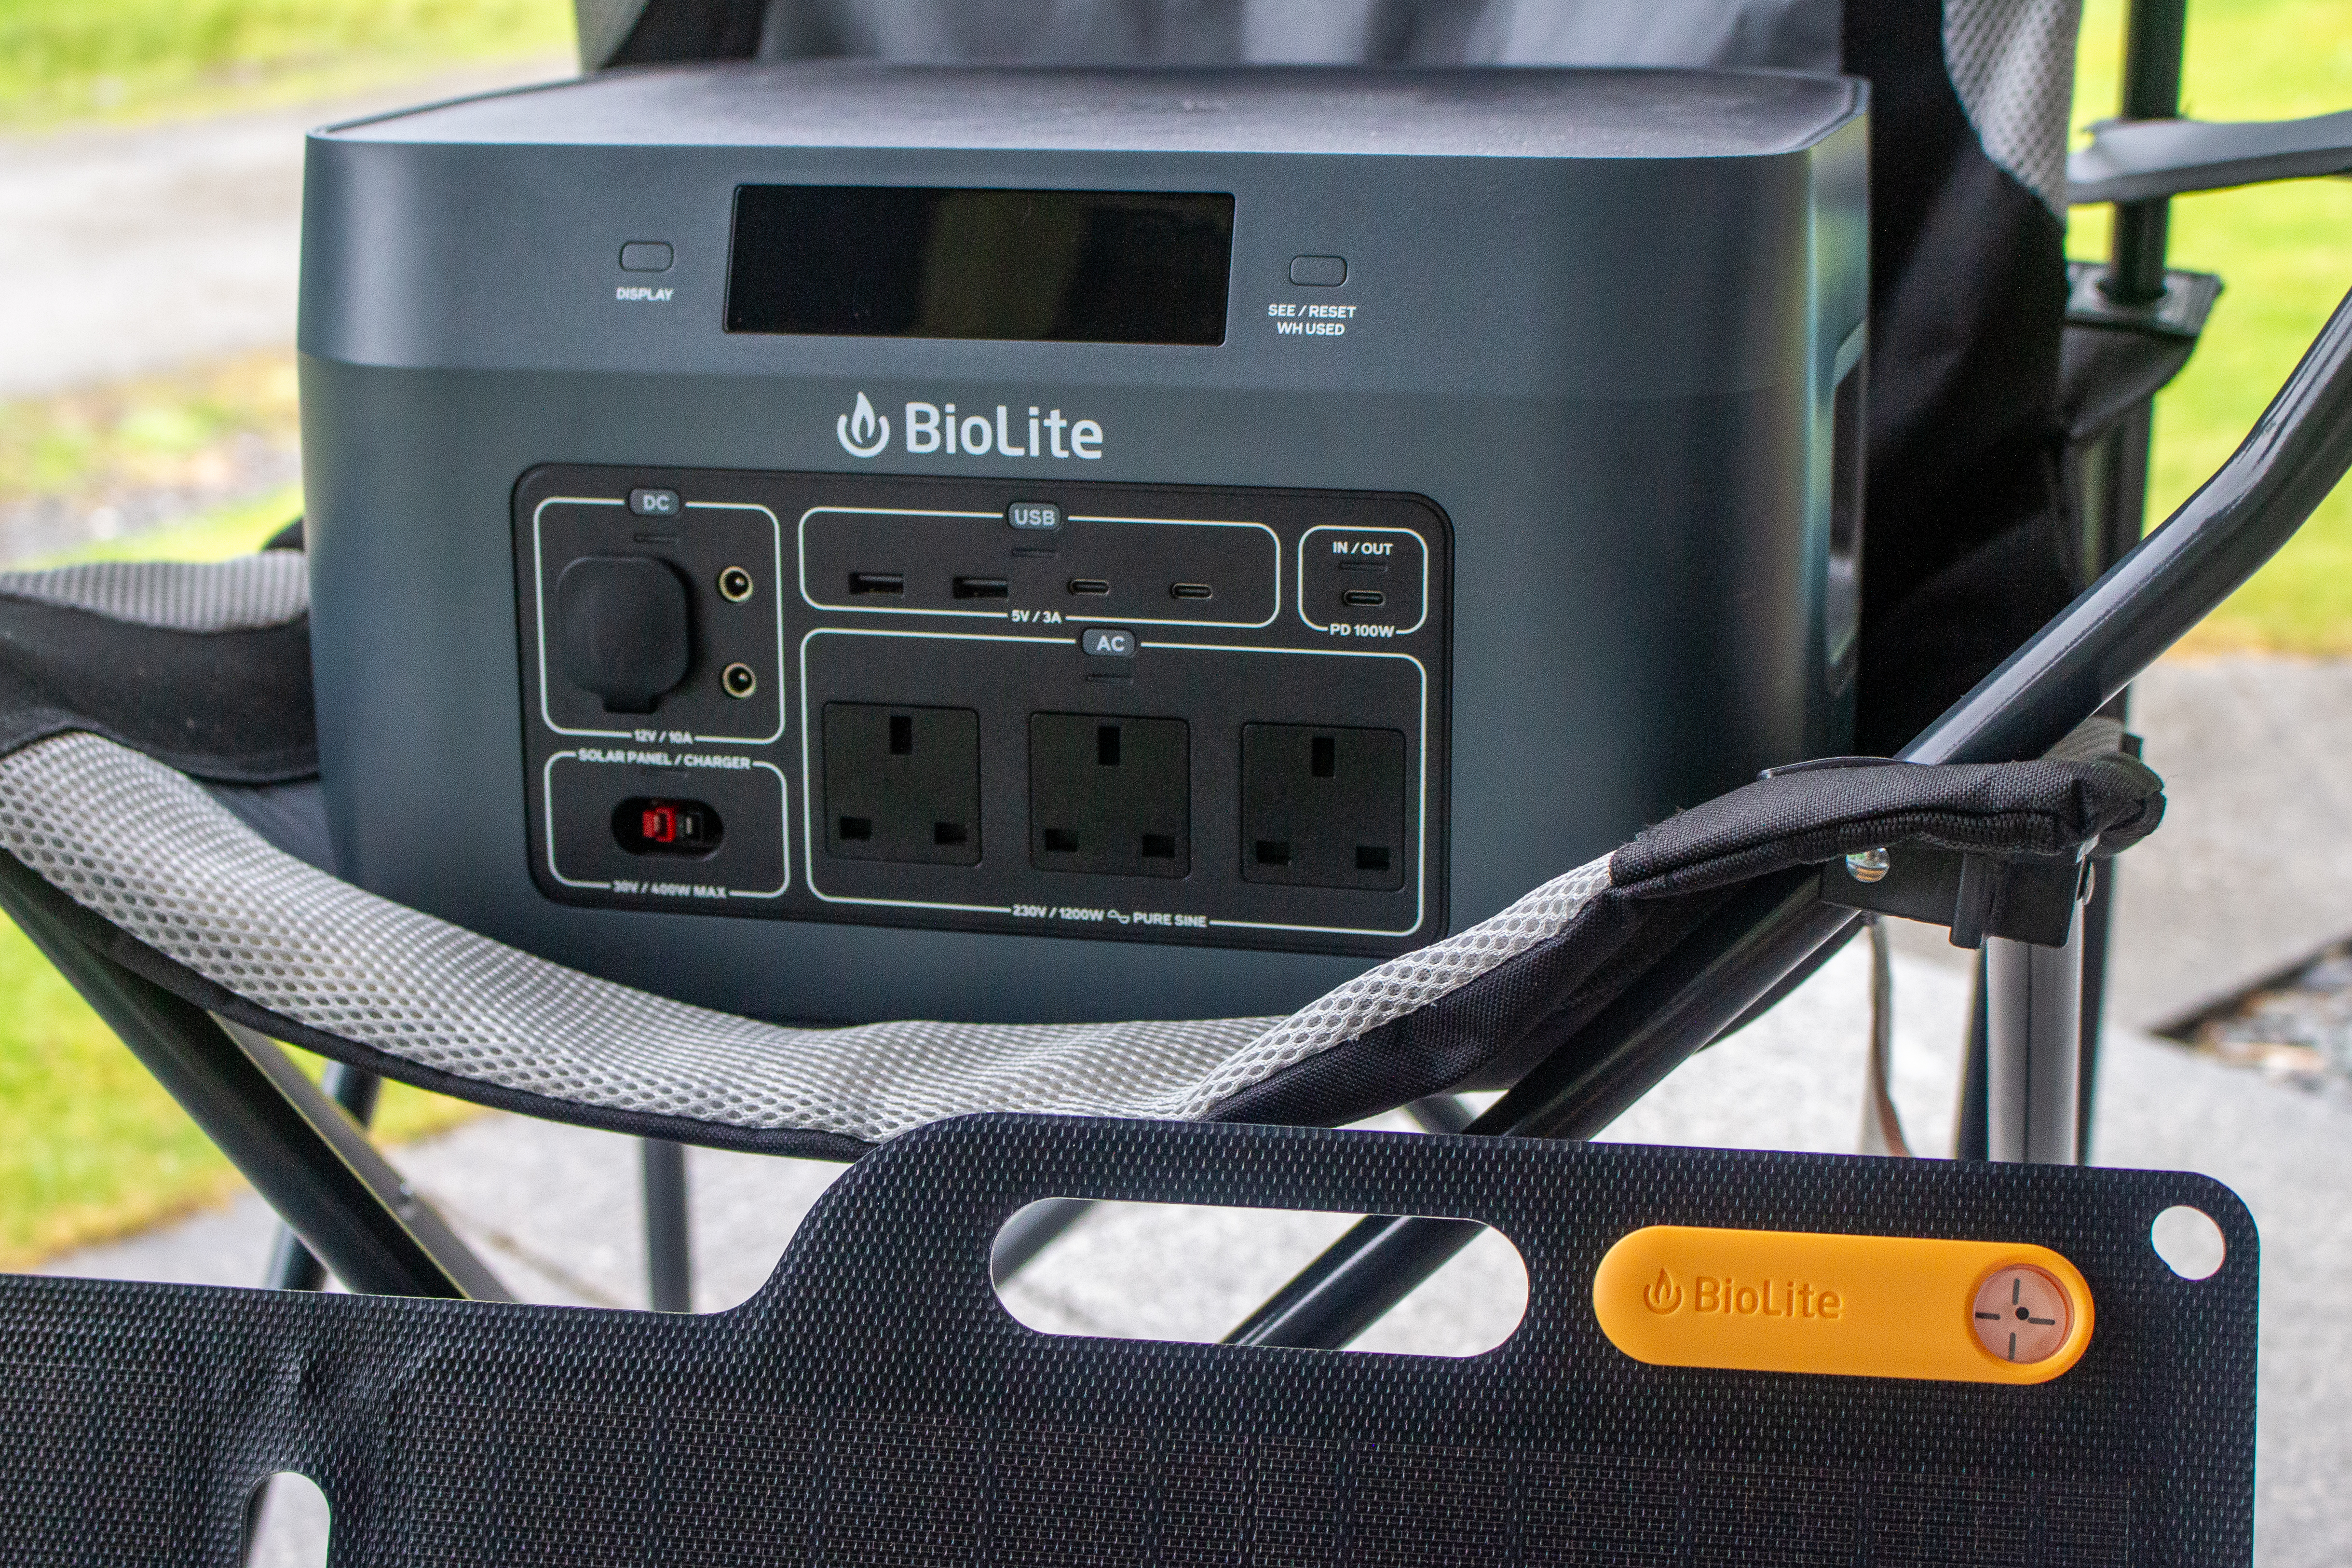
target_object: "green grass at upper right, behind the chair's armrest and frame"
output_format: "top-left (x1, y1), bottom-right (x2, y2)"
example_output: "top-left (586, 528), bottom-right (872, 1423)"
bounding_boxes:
top-left (2067, 0), bottom-right (2352, 656)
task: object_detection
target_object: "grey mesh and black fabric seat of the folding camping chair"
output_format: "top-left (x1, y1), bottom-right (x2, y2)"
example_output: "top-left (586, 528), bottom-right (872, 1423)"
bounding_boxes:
top-left (0, 550), bottom-right (2164, 1157)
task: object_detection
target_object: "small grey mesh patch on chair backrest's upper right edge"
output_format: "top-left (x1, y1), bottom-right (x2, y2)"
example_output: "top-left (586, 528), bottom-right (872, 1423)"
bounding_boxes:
top-left (1938, 0), bottom-right (2081, 218)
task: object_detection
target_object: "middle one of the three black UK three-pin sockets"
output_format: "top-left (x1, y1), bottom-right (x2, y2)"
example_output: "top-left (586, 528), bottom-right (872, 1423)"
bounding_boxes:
top-left (1030, 712), bottom-right (1193, 877)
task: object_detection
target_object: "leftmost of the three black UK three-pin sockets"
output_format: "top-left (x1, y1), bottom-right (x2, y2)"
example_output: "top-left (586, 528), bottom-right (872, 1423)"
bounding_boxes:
top-left (826, 703), bottom-right (981, 865)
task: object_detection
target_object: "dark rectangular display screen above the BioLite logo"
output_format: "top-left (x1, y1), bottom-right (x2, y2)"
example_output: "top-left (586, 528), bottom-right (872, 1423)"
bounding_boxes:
top-left (727, 186), bottom-right (1233, 345)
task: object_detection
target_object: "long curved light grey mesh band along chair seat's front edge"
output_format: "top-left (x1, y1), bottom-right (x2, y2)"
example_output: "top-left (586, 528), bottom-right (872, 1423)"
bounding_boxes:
top-left (0, 734), bottom-right (1609, 1143)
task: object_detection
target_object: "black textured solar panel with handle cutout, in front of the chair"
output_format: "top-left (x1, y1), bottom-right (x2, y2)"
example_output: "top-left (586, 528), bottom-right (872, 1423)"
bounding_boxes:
top-left (0, 1117), bottom-right (2258, 1568)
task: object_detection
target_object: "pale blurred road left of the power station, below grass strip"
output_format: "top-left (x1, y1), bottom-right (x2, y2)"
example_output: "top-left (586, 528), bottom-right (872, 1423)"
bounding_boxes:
top-left (0, 56), bottom-right (569, 397)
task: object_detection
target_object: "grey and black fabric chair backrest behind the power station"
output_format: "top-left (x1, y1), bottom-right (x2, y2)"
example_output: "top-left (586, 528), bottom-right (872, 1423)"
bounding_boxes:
top-left (574, 0), bottom-right (2081, 752)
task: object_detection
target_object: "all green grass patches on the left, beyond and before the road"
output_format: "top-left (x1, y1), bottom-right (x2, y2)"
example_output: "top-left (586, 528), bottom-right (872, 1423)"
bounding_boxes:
top-left (0, 0), bottom-right (571, 1269)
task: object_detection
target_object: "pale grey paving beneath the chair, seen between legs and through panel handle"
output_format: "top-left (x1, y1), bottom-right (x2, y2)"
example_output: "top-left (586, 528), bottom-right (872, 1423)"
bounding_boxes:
top-left (49, 947), bottom-right (2352, 1568)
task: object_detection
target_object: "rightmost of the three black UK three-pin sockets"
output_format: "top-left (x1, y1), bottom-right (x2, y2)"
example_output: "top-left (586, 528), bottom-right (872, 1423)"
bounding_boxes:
top-left (1242, 724), bottom-right (1404, 891)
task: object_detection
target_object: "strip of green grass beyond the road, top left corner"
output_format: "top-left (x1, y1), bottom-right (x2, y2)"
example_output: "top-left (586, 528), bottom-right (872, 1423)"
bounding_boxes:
top-left (0, 0), bottom-right (574, 129)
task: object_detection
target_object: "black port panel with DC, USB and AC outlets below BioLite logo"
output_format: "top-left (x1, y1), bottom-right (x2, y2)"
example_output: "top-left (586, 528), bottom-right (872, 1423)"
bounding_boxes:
top-left (515, 465), bottom-right (1451, 957)
